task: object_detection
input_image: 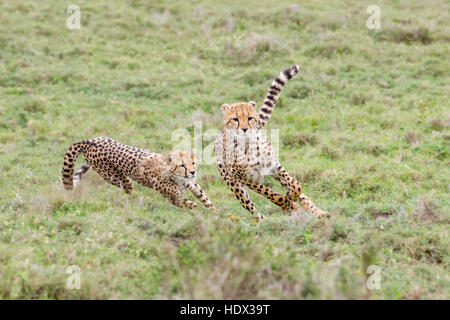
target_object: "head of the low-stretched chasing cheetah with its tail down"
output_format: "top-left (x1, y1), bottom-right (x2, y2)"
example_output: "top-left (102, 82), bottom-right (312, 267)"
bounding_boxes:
top-left (163, 150), bottom-right (198, 181)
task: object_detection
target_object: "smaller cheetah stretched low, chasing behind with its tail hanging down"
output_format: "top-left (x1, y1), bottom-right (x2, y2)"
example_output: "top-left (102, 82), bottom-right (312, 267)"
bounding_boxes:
top-left (62, 137), bottom-right (216, 210)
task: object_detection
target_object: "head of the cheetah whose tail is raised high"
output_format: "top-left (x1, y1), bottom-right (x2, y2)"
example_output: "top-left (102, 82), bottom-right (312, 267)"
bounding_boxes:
top-left (221, 101), bottom-right (259, 136)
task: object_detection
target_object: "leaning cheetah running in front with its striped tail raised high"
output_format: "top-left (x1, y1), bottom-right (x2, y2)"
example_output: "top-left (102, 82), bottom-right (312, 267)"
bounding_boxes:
top-left (214, 66), bottom-right (328, 221)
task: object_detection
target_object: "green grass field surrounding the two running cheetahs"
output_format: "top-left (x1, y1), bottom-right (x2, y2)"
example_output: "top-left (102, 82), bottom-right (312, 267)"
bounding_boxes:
top-left (0, 0), bottom-right (450, 299)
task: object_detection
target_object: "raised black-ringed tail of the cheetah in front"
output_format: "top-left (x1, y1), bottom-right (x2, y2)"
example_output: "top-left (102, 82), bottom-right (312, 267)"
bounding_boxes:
top-left (258, 65), bottom-right (299, 128)
